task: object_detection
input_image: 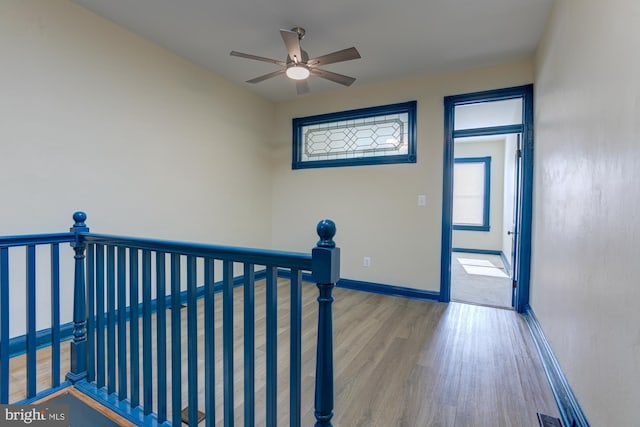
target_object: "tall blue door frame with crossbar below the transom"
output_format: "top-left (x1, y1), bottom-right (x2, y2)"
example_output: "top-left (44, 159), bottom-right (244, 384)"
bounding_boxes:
top-left (440, 84), bottom-right (533, 313)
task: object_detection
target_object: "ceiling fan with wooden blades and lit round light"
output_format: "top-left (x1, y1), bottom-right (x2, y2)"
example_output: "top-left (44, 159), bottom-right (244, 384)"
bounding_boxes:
top-left (231, 27), bottom-right (360, 95)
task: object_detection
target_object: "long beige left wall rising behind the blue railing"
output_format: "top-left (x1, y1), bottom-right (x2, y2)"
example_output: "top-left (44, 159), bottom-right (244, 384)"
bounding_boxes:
top-left (0, 0), bottom-right (276, 334)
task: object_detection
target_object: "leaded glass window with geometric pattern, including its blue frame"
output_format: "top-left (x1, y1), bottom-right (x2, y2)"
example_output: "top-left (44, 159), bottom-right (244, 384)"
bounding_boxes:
top-left (293, 101), bottom-right (416, 169)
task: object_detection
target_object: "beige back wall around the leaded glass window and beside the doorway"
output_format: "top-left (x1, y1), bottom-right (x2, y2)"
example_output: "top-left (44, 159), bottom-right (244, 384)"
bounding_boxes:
top-left (272, 61), bottom-right (533, 291)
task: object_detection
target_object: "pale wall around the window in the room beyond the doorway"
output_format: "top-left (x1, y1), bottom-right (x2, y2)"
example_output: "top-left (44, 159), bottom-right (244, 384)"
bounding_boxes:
top-left (451, 137), bottom-right (505, 252)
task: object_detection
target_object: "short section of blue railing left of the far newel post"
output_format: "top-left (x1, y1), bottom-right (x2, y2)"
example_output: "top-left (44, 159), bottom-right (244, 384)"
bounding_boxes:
top-left (0, 233), bottom-right (74, 404)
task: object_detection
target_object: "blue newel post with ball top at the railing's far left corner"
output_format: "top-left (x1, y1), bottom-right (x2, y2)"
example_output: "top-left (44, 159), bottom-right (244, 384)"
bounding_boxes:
top-left (67, 212), bottom-right (89, 383)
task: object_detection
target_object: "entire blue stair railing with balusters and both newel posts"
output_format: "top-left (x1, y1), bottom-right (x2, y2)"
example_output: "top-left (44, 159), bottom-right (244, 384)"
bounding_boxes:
top-left (0, 212), bottom-right (340, 426)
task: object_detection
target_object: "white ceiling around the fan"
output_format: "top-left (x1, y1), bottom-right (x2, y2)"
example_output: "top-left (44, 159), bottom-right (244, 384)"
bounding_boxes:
top-left (73, 0), bottom-right (553, 101)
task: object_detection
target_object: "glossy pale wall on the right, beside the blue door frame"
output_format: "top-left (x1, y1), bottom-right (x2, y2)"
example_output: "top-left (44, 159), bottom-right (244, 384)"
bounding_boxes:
top-left (531, 0), bottom-right (640, 426)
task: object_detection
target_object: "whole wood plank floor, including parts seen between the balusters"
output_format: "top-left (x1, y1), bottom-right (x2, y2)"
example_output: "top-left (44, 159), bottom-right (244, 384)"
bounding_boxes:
top-left (11, 281), bottom-right (558, 427)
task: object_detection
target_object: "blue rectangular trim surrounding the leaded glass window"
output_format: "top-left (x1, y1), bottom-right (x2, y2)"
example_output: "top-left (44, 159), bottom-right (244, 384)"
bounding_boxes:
top-left (291, 101), bottom-right (417, 169)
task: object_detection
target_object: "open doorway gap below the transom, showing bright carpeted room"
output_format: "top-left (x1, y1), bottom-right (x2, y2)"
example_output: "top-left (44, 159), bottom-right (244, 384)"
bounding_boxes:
top-left (450, 133), bottom-right (520, 308)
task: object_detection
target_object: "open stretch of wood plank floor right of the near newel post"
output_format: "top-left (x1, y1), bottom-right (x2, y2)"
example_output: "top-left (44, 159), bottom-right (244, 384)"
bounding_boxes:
top-left (328, 289), bottom-right (557, 427)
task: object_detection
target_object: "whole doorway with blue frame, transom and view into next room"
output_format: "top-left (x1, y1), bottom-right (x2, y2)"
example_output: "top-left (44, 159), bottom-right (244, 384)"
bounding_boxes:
top-left (440, 85), bottom-right (533, 312)
